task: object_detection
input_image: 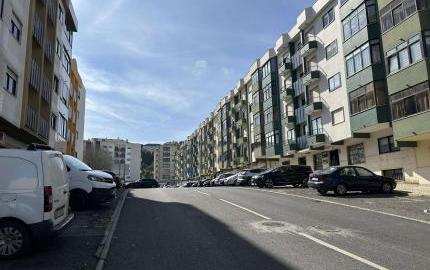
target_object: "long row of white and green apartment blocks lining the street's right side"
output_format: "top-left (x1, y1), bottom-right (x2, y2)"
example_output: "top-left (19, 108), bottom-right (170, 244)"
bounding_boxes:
top-left (176, 0), bottom-right (430, 184)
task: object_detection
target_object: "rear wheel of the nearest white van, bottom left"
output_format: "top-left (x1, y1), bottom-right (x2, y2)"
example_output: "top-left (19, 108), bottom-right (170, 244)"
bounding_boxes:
top-left (0, 221), bottom-right (30, 259)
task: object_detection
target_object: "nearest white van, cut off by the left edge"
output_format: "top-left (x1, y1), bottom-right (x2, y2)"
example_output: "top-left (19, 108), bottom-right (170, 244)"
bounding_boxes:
top-left (0, 149), bottom-right (73, 259)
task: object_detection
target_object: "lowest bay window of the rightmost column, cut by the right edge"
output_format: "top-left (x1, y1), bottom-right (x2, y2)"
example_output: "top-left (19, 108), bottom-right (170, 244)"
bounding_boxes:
top-left (391, 82), bottom-right (430, 120)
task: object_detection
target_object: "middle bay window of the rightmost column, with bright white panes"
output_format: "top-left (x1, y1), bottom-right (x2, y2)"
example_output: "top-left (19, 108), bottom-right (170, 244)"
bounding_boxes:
top-left (387, 35), bottom-right (423, 74)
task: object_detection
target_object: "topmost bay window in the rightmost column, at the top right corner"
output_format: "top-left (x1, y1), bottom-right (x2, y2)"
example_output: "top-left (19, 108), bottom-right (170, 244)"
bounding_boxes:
top-left (380, 0), bottom-right (425, 32)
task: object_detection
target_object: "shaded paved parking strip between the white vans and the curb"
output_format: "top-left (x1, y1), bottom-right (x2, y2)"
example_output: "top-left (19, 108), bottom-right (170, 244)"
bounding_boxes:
top-left (0, 191), bottom-right (122, 270)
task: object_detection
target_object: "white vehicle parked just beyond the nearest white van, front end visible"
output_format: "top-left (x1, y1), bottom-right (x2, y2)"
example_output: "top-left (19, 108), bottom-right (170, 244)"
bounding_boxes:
top-left (64, 155), bottom-right (116, 210)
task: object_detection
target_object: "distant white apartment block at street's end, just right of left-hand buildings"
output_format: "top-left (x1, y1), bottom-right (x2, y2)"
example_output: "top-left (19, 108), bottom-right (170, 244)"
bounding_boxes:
top-left (84, 138), bottom-right (142, 182)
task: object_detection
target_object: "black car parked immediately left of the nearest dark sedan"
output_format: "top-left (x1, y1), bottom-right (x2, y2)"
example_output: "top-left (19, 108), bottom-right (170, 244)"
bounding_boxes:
top-left (252, 165), bottom-right (312, 188)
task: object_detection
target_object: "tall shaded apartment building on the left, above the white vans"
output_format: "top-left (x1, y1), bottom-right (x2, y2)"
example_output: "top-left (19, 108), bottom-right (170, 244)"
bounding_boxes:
top-left (0, 0), bottom-right (85, 155)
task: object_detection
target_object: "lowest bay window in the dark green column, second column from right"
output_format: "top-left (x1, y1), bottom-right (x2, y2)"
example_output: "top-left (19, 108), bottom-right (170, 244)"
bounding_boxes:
top-left (349, 81), bottom-right (387, 115)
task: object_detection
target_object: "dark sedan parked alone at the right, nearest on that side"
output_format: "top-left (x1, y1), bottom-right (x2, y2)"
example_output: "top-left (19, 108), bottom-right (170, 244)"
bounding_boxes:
top-left (308, 166), bottom-right (396, 195)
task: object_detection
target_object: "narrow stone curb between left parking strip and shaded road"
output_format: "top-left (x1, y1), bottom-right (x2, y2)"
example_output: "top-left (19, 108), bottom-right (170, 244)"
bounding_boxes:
top-left (95, 189), bottom-right (128, 270)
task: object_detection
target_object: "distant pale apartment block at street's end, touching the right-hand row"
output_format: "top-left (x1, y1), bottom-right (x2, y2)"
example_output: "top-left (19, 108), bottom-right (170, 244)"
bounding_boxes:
top-left (154, 142), bottom-right (179, 183)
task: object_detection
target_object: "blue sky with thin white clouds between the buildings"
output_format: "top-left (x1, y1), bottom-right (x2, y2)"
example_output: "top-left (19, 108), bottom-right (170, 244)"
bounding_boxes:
top-left (72, 0), bottom-right (314, 143)
